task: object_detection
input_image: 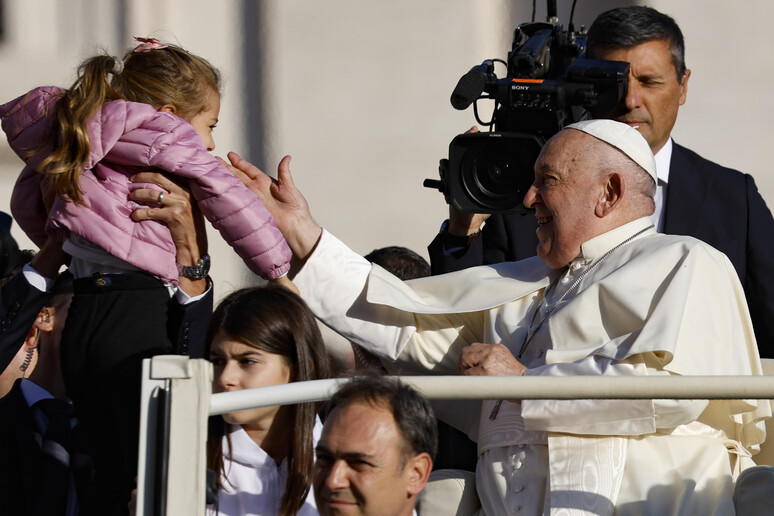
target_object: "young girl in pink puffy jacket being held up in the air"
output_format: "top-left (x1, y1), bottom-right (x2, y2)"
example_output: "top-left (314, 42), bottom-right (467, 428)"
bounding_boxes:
top-left (0, 38), bottom-right (291, 514)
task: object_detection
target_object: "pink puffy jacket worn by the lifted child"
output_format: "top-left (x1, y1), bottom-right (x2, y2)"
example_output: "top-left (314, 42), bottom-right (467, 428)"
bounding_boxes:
top-left (0, 87), bottom-right (291, 284)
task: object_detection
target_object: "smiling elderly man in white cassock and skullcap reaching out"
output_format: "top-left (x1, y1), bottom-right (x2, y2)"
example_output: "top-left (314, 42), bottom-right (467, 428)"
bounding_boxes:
top-left (224, 120), bottom-right (771, 516)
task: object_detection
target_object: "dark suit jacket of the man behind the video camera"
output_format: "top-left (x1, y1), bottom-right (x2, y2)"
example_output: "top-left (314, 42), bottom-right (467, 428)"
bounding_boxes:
top-left (428, 143), bottom-right (774, 358)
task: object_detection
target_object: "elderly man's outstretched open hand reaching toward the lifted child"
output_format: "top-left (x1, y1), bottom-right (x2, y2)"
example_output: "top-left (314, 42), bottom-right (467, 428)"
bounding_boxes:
top-left (220, 152), bottom-right (322, 260)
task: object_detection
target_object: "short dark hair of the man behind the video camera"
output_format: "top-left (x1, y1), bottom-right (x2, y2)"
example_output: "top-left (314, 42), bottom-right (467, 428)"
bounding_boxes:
top-left (586, 5), bottom-right (685, 82)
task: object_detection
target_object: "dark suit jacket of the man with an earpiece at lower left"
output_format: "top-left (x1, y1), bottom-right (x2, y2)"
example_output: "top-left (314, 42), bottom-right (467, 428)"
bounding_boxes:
top-left (0, 378), bottom-right (43, 516)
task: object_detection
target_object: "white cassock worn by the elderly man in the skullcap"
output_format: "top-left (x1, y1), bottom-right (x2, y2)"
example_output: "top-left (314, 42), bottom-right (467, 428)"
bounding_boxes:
top-left (294, 218), bottom-right (771, 516)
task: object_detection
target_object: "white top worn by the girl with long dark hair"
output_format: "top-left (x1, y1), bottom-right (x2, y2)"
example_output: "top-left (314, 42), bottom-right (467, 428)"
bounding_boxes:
top-left (207, 418), bottom-right (322, 516)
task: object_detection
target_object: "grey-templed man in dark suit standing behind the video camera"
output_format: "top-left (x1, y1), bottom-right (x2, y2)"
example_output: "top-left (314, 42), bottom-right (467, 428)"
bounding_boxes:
top-left (428, 6), bottom-right (774, 357)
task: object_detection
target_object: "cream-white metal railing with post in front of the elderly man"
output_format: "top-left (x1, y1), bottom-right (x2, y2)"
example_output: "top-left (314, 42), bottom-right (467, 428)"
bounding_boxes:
top-left (137, 356), bottom-right (774, 516)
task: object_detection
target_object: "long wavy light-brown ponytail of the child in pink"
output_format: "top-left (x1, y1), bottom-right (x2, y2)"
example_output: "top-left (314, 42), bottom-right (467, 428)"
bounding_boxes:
top-left (41, 55), bottom-right (122, 203)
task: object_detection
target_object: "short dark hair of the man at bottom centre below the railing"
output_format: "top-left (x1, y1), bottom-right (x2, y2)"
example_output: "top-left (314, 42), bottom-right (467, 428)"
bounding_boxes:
top-left (326, 375), bottom-right (438, 460)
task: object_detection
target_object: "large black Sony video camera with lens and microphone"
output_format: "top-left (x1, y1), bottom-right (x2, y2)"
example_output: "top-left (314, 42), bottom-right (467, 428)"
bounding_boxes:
top-left (424, 18), bottom-right (629, 213)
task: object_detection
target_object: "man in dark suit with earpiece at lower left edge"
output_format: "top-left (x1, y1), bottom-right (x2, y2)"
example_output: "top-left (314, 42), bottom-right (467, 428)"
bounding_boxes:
top-left (0, 273), bottom-right (79, 516)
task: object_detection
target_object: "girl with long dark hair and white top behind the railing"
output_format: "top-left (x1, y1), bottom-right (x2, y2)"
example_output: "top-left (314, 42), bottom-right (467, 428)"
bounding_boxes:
top-left (207, 286), bottom-right (328, 516)
